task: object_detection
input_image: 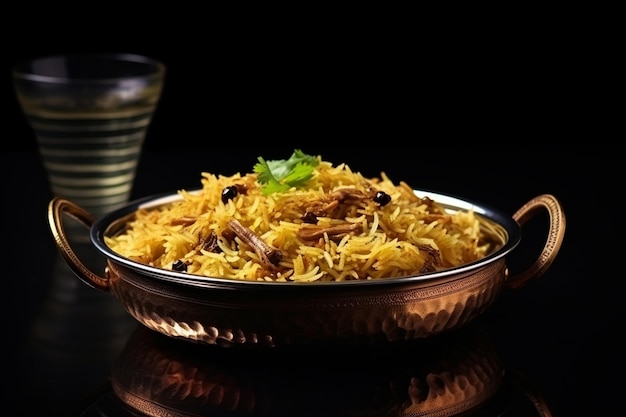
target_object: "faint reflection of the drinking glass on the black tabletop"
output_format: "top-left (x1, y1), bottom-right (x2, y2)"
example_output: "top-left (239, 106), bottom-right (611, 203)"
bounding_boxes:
top-left (22, 243), bottom-right (137, 415)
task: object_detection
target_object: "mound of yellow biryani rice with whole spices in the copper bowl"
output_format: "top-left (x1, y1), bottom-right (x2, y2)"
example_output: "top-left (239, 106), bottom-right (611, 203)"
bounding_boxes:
top-left (105, 157), bottom-right (489, 282)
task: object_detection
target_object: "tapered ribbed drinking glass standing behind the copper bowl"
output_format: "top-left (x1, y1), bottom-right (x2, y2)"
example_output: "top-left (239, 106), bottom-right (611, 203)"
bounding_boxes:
top-left (12, 53), bottom-right (166, 217)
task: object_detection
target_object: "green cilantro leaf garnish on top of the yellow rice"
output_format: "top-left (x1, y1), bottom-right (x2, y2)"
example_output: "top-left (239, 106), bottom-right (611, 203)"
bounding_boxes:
top-left (254, 149), bottom-right (319, 195)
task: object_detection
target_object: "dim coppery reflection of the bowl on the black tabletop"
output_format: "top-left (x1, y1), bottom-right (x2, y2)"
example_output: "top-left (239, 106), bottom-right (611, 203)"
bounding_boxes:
top-left (75, 326), bottom-right (545, 417)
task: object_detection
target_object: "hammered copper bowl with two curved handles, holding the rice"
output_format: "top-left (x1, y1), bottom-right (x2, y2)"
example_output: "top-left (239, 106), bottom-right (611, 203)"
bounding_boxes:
top-left (48, 190), bottom-right (565, 346)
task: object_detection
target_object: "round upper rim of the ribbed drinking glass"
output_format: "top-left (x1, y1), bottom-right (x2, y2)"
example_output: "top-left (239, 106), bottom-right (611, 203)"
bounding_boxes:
top-left (13, 53), bottom-right (166, 84)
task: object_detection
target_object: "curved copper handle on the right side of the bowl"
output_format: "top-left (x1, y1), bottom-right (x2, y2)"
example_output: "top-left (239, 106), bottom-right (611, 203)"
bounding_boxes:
top-left (507, 194), bottom-right (565, 288)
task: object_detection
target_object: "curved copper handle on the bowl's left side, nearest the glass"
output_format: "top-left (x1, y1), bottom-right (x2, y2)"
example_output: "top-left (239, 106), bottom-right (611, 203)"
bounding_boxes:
top-left (48, 197), bottom-right (109, 291)
